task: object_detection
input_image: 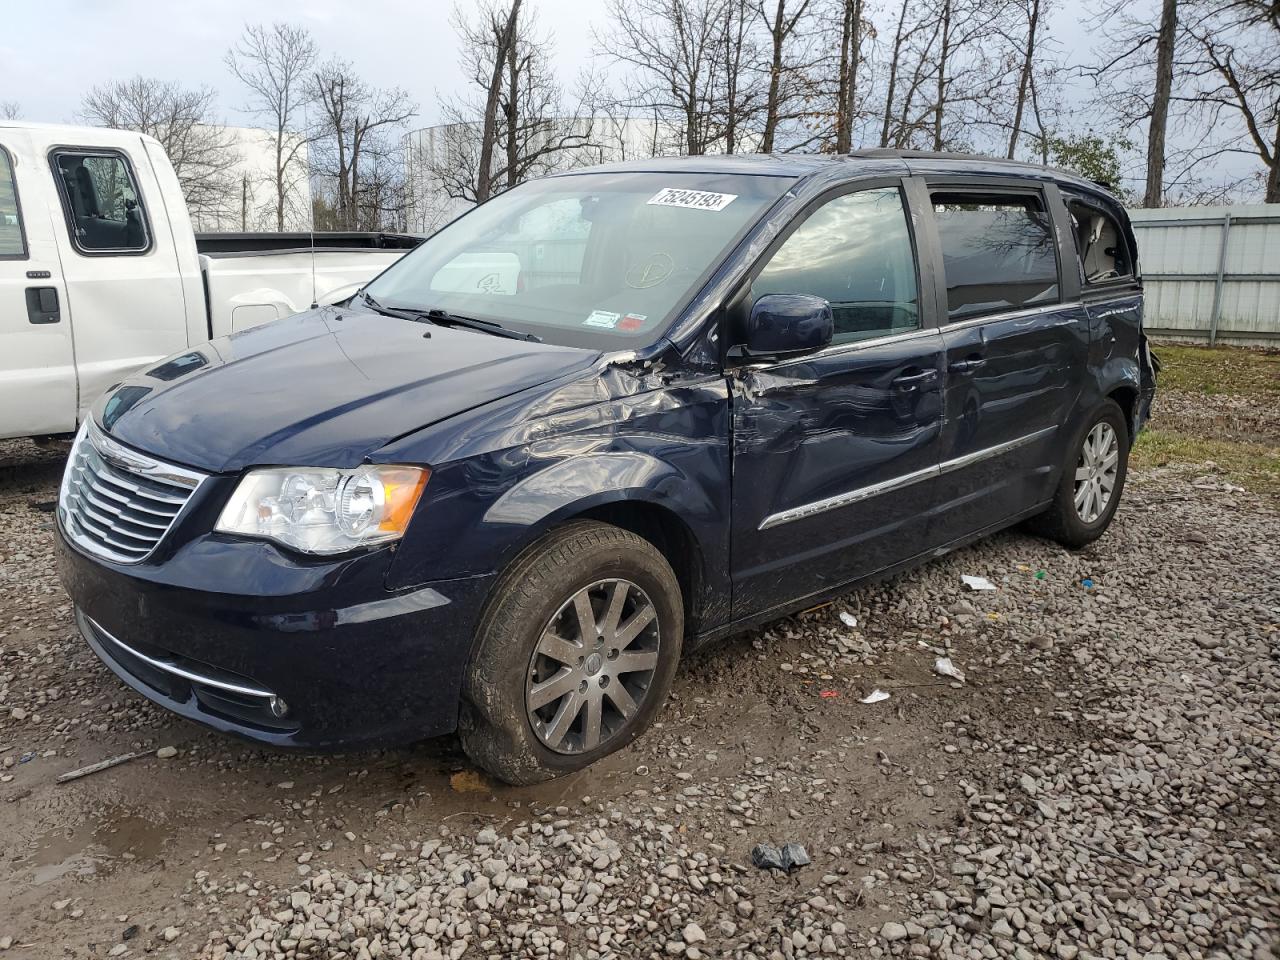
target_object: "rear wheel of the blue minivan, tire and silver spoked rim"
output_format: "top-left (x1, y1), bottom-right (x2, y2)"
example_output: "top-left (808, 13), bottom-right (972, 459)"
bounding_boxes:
top-left (1029, 399), bottom-right (1129, 548)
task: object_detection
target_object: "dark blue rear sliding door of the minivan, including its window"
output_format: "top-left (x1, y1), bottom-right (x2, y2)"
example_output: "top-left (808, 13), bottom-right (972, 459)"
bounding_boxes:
top-left (928, 182), bottom-right (1089, 543)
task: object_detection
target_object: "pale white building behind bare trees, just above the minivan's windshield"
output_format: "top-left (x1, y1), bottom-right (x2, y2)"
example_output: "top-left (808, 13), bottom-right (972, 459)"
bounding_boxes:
top-left (404, 116), bottom-right (684, 233)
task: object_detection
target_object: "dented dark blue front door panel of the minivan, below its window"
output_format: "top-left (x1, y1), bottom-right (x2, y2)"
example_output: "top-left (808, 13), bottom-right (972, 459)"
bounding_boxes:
top-left (732, 330), bottom-right (942, 617)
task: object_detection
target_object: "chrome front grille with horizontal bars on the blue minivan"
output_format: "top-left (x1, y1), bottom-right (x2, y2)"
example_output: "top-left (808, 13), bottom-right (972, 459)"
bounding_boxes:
top-left (58, 420), bottom-right (205, 563)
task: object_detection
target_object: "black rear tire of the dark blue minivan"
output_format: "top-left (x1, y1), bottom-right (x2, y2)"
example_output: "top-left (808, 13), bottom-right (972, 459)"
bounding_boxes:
top-left (1028, 399), bottom-right (1129, 549)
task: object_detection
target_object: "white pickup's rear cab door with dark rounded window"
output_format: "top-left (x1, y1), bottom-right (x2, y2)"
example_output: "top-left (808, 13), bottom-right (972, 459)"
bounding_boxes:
top-left (47, 138), bottom-right (187, 419)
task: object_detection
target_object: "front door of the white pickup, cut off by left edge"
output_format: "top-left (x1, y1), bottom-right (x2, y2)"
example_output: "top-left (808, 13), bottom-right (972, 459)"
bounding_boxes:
top-left (0, 127), bottom-right (76, 438)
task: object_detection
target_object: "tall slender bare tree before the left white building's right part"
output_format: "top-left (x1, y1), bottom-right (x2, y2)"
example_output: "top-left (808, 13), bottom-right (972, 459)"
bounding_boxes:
top-left (224, 23), bottom-right (316, 230)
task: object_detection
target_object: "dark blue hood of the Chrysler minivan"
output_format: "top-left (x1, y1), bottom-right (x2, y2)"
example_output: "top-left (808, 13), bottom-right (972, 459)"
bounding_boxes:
top-left (95, 307), bottom-right (599, 472)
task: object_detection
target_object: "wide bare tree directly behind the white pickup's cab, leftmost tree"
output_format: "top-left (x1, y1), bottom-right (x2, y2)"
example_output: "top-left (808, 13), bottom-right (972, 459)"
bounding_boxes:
top-left (79, 77), bottom-right (238, 220)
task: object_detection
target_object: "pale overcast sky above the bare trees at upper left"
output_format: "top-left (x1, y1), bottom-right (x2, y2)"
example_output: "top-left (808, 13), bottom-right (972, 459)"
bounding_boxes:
top-left (0, 0), bottom-right (604, 125)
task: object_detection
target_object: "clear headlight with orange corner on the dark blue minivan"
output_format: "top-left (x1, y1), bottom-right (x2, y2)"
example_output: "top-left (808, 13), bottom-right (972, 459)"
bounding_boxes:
top-left (216, 466), bottom-right (431, 553)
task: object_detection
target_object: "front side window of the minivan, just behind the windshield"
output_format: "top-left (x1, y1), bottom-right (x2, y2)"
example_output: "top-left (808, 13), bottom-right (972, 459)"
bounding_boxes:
top-left (751, 188), bottom-right (920, 343)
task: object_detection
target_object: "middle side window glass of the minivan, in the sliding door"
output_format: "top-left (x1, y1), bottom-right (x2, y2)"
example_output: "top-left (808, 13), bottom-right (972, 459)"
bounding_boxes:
top-left (932, 192), bottom-right (1059, 323)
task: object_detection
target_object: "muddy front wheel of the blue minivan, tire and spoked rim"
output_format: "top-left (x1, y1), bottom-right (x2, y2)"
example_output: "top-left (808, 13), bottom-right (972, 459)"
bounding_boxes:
top-left (458, 521), bottom-right (685, 785)
